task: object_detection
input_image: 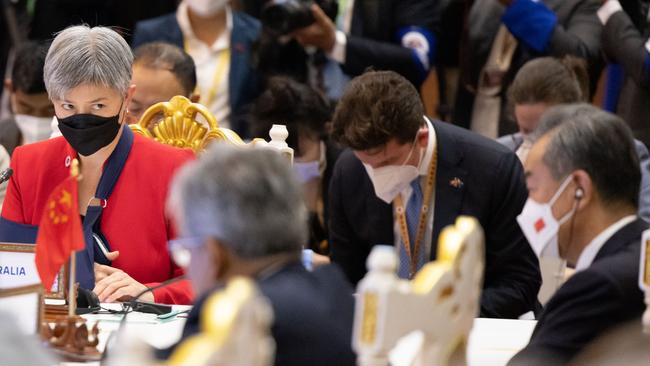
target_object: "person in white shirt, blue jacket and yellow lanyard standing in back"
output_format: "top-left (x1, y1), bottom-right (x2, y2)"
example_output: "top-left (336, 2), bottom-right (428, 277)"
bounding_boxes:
top-left (131, 0), bottom-right (260, 138)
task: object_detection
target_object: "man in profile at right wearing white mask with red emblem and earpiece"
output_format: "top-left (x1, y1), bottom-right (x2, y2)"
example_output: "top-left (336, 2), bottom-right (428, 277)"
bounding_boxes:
top-left (510, 104), bottom-right (648, 365)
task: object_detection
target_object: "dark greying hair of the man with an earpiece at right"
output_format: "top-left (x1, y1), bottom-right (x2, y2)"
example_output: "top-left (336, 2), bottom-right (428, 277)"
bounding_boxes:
top-left (532, 103), bottom-right (641, 207)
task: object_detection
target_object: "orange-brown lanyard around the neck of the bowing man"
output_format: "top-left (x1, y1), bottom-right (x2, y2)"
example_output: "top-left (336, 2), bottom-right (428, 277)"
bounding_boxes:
top-left (394, 148), bottom-right (438, 279)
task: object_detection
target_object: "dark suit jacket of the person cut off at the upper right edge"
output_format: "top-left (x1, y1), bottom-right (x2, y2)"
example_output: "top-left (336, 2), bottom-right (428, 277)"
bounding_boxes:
top-left (602, 11), bottom-right (650, 146)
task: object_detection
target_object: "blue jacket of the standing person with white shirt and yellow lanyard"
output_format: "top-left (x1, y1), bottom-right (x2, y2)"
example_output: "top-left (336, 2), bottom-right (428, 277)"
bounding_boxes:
top-left (132, 11), bottom-right (260, 138)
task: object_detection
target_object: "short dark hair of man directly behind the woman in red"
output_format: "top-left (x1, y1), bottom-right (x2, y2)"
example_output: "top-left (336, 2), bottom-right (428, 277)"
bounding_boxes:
top-left (133, 42), bottom-right (196, 96)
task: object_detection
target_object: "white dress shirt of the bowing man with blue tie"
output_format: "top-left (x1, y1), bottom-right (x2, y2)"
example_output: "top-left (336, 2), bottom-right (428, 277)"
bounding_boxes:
top-left (393, 117), bottom-right (437, 263)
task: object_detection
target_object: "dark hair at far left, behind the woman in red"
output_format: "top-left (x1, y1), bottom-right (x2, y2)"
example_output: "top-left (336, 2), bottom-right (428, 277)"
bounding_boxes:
top-left (11, 41), bottom-right (49, 94)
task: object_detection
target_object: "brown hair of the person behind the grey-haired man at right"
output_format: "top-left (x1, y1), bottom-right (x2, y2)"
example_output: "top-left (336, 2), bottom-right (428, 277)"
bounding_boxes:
top-left (508, 56), bottom-right (589, 106)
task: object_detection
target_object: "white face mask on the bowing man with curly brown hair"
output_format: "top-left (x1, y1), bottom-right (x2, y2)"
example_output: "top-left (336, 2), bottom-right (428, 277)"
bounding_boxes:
top-left (363, 136), bottom-right (424, 204)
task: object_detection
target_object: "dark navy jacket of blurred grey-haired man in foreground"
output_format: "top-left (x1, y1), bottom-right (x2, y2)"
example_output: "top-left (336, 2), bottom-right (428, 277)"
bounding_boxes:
top-left (168, 263), bottom-right (356, 366)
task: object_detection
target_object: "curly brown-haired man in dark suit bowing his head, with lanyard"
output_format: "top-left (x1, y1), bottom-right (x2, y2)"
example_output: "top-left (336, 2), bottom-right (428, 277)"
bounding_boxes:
top-left (330, 71), bottom-right (541, 318)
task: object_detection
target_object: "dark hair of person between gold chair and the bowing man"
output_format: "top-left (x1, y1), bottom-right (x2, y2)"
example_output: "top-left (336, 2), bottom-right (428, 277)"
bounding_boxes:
top-left (251, 77), bottom-right (332, 155)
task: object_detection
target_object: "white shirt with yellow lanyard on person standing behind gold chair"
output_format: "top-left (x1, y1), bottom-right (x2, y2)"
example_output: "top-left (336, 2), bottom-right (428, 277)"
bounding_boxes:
top-left (176, 2), bottom-right (233, 128)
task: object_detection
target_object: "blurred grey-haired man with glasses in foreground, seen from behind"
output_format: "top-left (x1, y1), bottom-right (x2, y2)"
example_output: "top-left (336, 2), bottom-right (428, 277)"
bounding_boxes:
top-left (165, 144), bottom-right (355, 366)
